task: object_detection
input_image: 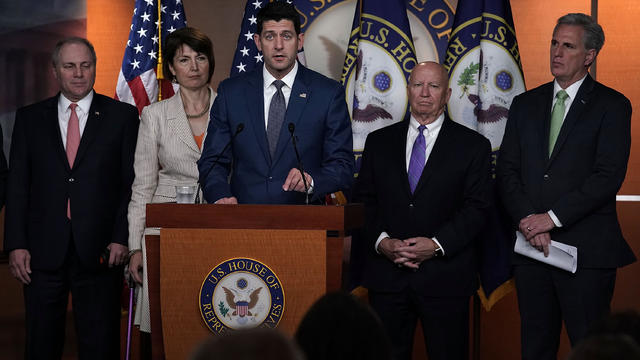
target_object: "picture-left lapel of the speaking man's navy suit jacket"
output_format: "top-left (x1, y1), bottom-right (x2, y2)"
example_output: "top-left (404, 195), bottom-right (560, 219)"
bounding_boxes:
top-left (245, 67), bottom-right (271, 164)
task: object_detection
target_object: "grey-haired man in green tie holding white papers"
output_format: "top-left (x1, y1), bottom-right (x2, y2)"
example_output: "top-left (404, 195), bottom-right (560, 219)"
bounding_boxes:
top-left (497, 14), bottom-right (635, 360)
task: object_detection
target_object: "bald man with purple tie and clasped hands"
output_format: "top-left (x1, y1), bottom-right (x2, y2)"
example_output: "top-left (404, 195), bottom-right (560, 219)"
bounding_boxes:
top-left (355, 62), bottom-right (491, 360)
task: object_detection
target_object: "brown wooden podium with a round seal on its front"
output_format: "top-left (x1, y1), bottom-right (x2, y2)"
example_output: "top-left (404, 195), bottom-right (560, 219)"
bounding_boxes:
top-left (146, 204), bottom-right (364, 359)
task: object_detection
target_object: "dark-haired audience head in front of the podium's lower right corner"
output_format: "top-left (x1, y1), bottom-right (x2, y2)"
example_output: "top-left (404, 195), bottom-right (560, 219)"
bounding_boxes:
top-left (295, 292), bottom-right (392, 360)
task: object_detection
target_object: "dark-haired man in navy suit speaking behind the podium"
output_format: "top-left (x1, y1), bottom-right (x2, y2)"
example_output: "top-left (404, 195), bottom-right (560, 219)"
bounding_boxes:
top-left (198, 1), bottom-right (354, 204)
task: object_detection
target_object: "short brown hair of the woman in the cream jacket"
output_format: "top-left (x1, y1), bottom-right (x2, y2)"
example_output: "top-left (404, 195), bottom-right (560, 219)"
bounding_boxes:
top-left (162, 27), bottom-right (216, 81)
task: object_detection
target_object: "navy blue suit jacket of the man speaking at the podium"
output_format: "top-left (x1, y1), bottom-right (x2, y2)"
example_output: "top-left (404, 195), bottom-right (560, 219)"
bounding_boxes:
top-left (198, 66), bottom-right (354, 204)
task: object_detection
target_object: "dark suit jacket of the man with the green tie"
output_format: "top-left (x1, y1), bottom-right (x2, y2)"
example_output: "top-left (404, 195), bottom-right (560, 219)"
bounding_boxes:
top-left (497, 75), bottom-right (635, 268)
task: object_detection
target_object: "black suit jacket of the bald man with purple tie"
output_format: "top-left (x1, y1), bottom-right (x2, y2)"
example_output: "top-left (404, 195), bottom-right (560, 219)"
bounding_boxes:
top-left (355, 118), bottom-right (491, 296)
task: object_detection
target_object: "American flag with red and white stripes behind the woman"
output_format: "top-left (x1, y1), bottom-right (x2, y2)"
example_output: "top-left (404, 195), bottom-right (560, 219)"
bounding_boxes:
top-left (116, 0), bottom-right (187, 112)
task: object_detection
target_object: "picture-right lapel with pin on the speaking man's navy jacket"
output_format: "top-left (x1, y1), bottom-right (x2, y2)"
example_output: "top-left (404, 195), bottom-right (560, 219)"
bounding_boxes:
top-left (273, 65), bottom-right (312, 164)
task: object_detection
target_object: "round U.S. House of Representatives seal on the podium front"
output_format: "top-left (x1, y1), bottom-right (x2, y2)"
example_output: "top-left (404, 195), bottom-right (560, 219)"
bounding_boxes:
top-left (198, 258), bottom-right (285, 334)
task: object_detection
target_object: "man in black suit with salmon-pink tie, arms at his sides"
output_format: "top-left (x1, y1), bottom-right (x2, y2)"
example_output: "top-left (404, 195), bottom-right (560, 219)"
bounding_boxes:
top-left (4, 38), bottom-right (138, 359)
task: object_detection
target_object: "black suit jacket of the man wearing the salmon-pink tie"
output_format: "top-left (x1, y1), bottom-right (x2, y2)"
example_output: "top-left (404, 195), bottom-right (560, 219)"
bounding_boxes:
top-left (4, 93), bottom-right (139, 270)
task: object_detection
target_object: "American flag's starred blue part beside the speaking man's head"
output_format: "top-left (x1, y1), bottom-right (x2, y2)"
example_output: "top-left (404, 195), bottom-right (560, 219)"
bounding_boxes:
top-left (230, 0), bottom-right (305, 76)
